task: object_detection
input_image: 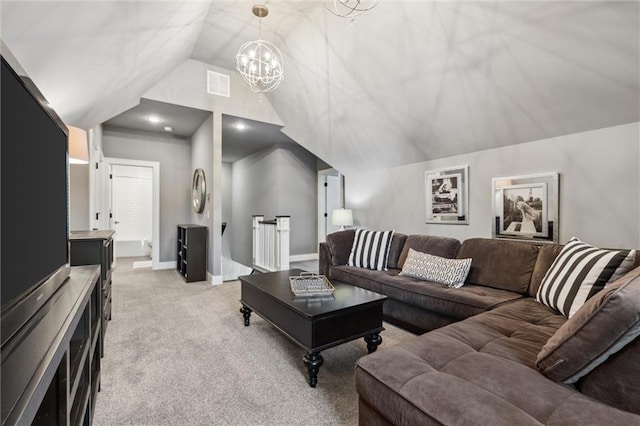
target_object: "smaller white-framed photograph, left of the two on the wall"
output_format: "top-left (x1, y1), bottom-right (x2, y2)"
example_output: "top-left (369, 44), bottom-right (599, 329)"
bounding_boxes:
top-left (424, 166), bottom-right (469, 224)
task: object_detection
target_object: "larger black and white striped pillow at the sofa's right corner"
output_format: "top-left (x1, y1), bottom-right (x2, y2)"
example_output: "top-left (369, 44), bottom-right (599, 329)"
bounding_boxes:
top-left (536, 237), bottom-right (636, 318)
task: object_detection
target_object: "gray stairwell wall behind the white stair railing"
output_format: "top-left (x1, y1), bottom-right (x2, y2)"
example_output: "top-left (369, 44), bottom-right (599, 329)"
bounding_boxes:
top-left (231, 145), bottom-right (318, 266)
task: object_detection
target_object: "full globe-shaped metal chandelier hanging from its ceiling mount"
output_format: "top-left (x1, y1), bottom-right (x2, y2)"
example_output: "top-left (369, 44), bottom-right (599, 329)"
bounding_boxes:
top-left (236, 5), bottom-right (284, 93)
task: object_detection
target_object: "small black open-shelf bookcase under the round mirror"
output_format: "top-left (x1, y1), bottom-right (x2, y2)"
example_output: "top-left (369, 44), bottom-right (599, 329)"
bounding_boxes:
top-left (176, 225), bottom-right (207, 282)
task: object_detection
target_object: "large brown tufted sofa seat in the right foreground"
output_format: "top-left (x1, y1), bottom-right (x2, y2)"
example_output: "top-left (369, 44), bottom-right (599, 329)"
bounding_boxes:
top-left (356, 300), bottom-right (637, 425)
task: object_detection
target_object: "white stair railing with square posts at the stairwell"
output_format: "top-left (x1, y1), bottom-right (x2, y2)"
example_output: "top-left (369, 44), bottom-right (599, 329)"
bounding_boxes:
top-left (252, 215), bottom-right (291, 272)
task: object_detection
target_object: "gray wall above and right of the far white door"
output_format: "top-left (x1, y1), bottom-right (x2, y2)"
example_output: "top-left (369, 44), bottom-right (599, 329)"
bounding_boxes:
top-left (102, 129), bottom-right (192, 262)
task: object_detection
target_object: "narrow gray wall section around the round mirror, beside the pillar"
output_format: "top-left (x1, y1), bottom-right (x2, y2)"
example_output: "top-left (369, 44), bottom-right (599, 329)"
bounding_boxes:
top-left (189, 115), bottom-right (213, 274)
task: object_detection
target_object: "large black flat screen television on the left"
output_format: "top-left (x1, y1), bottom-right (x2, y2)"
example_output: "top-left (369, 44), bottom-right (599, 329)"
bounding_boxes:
top-left (0, 55), bottom-right (69, 350)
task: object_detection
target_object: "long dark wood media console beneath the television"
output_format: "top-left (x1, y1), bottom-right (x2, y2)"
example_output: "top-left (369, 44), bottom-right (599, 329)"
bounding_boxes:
top-left (2, 266), bottom-right (102, 425)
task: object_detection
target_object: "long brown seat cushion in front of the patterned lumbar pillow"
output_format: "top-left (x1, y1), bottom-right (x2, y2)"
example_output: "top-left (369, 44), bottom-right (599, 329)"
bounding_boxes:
top-left (329, 266), bottom-right (522, 319)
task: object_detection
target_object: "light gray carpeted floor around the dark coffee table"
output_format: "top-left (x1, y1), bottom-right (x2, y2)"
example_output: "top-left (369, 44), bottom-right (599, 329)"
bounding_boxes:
top-left (94, 258), bottom-right (411, 426)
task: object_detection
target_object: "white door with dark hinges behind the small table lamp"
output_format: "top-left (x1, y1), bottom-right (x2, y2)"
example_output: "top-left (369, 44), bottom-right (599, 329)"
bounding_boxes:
top-left (318, 169), bottom-right (344, 243)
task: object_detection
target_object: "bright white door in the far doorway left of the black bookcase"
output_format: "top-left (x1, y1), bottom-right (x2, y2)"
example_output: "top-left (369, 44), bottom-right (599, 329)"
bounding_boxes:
top-left (110, 164), bottom-right (153, 257)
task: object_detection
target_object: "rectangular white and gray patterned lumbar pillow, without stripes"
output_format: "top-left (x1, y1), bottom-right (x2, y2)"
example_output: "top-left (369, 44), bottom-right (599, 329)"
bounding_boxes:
top-left (400, 249), bottom-right (471, 288)
